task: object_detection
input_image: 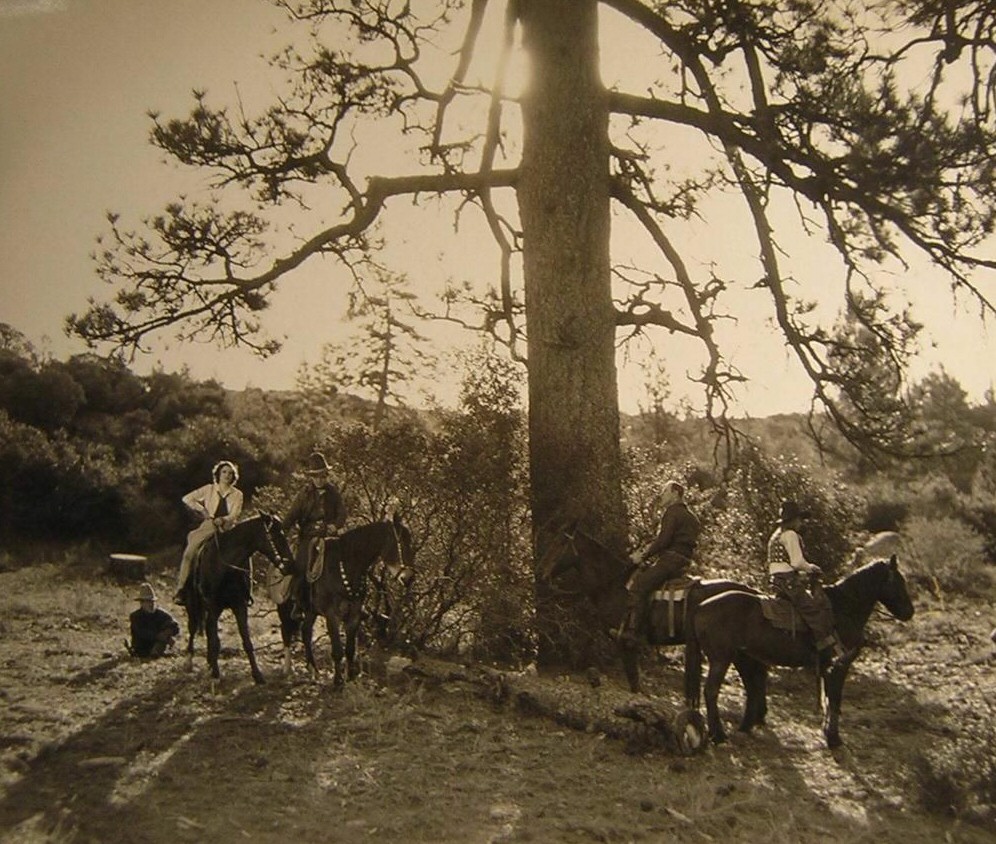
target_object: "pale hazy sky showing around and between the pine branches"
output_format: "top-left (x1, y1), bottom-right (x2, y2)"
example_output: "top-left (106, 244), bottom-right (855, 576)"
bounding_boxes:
top-left (0, 0), bottom-right (996, 416)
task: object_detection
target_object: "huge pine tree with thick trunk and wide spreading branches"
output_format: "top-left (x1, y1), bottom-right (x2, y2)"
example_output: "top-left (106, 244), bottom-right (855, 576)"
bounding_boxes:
top-left (70, 0), bottom-right (996, 656)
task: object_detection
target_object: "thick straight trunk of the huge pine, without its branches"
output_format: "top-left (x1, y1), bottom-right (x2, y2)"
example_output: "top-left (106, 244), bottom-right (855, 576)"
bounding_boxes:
top-left (518, 0), bottom-right (626, 658)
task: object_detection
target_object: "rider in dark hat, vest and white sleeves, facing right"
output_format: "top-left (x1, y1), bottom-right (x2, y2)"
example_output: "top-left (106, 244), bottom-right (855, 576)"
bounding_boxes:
top-left (768, 501), bottom-right (847, 671)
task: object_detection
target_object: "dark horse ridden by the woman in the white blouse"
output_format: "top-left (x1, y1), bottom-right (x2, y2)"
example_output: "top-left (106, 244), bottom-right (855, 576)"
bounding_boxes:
top-left (184, 513), bottom-right (291, 683)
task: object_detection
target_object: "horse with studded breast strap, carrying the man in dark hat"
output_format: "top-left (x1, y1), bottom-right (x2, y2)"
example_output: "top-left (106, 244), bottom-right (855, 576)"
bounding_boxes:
top-left (277, 513), bottom-right (415, 688)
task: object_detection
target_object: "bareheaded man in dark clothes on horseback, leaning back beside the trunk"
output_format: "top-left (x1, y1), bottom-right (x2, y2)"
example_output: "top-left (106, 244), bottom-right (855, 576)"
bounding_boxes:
top-left (618, 481), bottom-right (701, 641)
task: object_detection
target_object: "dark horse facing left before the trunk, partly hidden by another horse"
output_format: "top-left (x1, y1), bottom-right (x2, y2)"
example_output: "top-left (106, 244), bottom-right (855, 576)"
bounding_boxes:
top-left (540, 525), bottom-right (756, 692)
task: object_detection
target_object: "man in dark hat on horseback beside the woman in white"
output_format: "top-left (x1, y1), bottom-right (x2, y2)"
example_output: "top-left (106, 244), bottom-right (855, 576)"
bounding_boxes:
top-left (283, 451), bottom-right (346, 610)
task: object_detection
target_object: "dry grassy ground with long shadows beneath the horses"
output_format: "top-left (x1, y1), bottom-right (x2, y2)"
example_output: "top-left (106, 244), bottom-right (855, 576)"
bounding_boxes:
top-left (0, 564), bottom-right (996, 844)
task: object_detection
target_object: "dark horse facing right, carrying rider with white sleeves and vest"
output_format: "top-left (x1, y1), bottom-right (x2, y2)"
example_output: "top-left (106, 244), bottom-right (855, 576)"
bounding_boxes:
top-left (685, 555), bottom-right (914, 749)
